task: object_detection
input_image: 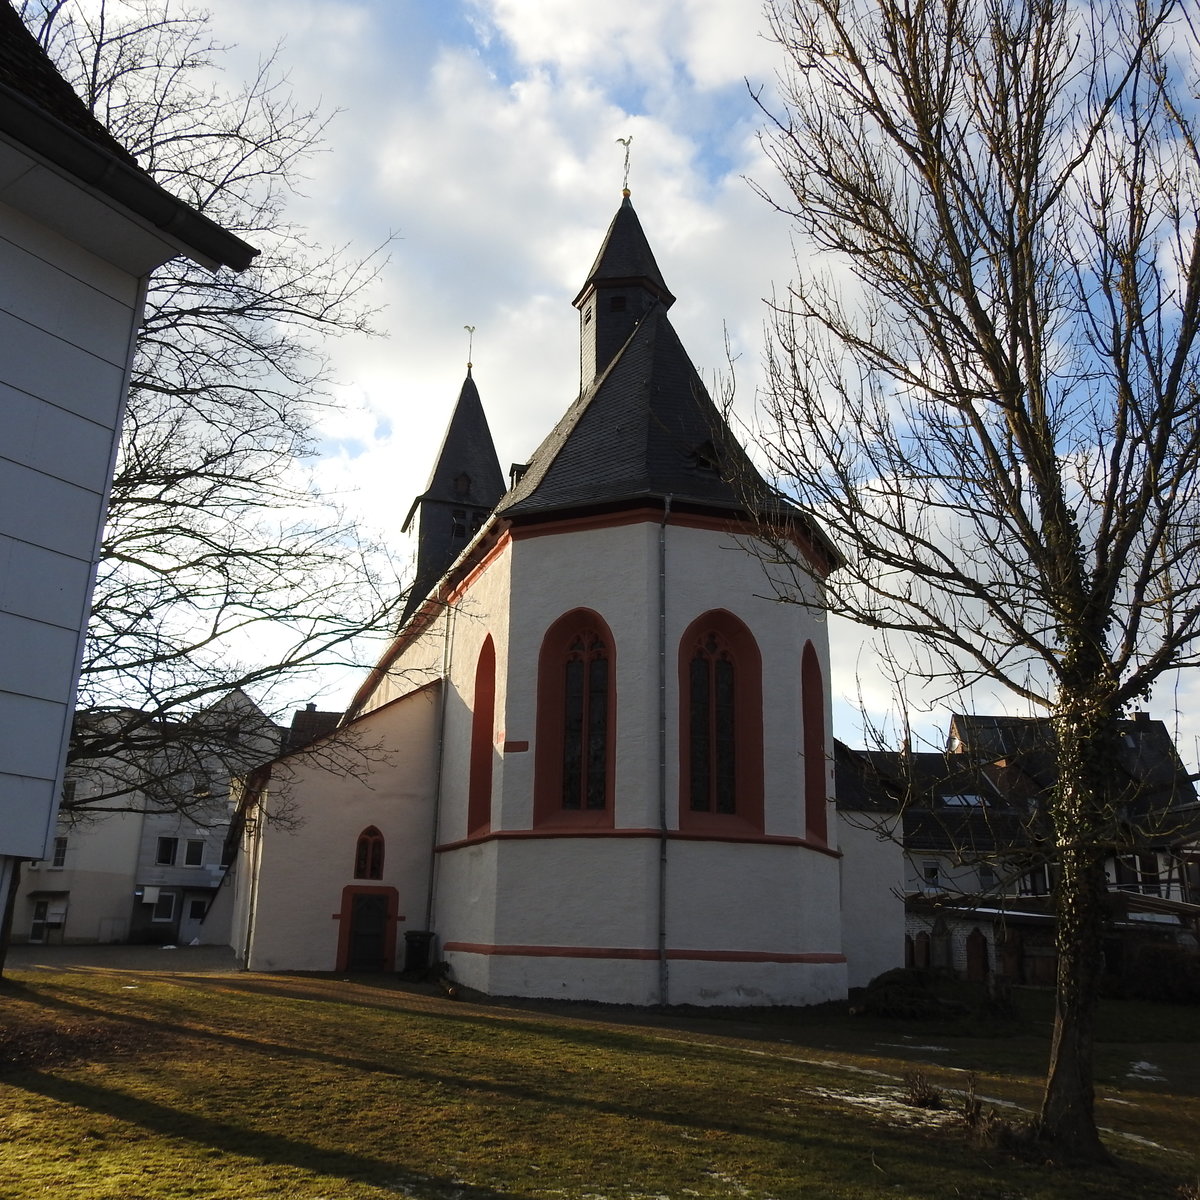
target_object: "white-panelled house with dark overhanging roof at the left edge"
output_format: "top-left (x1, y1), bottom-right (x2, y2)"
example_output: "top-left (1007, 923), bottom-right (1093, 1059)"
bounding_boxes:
top-left (0, 0), bottom-right (256, 916)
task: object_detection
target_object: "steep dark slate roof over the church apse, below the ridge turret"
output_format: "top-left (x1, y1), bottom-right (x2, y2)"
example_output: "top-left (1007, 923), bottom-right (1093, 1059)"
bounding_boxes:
top-left (498, 304), bottom-right (794, 518)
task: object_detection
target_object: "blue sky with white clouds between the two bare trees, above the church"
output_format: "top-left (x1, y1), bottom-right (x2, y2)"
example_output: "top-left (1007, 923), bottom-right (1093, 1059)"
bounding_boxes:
top-left (187, 0), bottom-right (1194, 758)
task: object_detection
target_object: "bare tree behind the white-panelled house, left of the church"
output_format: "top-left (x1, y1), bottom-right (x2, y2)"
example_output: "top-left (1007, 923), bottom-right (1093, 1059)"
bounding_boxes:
top-left (23, 0), bottom-right (400, 809)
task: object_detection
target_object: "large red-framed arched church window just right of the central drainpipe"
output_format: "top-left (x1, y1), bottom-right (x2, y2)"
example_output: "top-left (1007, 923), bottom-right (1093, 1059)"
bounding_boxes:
top-left (679, 610), bottom-right (763, 834)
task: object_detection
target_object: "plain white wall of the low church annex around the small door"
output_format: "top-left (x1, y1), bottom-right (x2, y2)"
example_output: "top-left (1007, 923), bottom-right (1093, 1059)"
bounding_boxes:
top-left (236, 688), bottom-right (439, 971)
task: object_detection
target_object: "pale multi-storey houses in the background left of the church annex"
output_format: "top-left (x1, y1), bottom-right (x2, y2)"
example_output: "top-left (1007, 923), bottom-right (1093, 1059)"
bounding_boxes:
top-left (12, 691), bottom-right (282, 946)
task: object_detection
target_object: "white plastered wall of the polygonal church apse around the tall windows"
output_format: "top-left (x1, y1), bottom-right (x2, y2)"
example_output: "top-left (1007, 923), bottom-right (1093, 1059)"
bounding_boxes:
top-left (437, 521), bottom-right (846, 1004)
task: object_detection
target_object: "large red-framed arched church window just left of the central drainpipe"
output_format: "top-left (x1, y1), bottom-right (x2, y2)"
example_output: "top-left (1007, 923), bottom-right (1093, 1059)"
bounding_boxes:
top-left (533, 608), bottom-right (617, 829)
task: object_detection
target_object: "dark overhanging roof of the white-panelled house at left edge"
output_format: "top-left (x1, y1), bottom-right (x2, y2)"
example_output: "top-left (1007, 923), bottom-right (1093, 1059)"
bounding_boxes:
top-left (0, 0), bottom-right (258, 271)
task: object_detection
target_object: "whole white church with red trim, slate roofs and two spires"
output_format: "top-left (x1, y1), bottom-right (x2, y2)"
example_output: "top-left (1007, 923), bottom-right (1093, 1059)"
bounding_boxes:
top-left (234, 193), bottom-right (902, 1004)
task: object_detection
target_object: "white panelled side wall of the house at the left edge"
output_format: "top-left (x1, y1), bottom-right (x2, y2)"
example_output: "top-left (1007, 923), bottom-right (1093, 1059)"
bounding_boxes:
top-left (0, 192), bottom-right (140, 858)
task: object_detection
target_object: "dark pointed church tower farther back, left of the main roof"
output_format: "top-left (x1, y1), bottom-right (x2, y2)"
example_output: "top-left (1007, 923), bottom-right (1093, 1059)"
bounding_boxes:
top-left (402, 369), bottom-right (504, 620)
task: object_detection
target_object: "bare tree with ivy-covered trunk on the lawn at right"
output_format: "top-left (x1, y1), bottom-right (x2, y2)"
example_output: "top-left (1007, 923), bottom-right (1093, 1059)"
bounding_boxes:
top-left (764, 0), bottom-right (1200, 1159)
